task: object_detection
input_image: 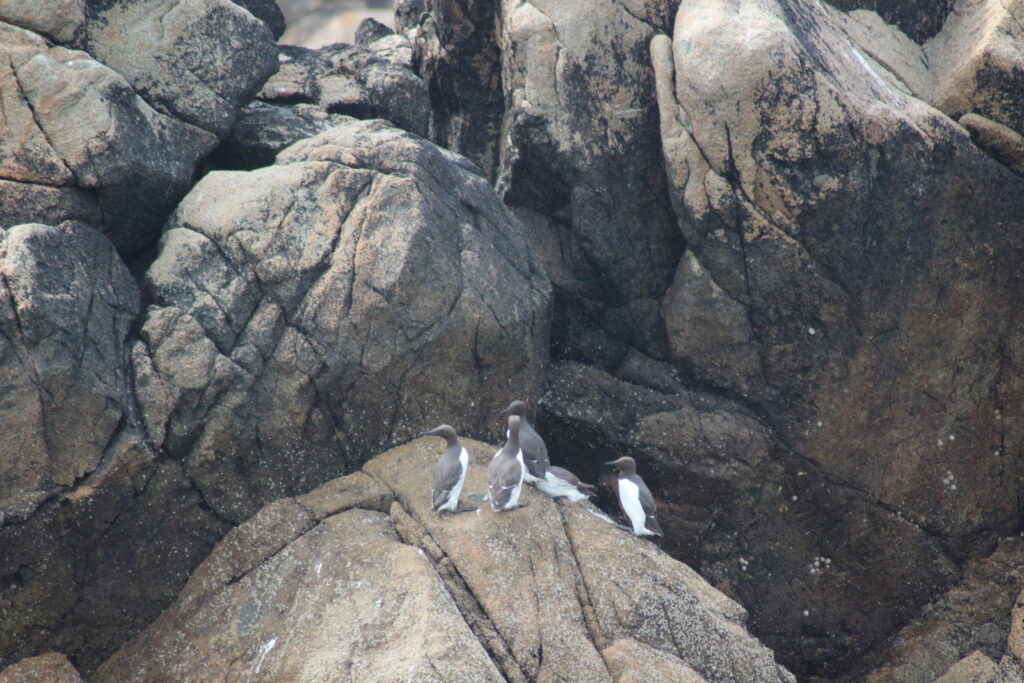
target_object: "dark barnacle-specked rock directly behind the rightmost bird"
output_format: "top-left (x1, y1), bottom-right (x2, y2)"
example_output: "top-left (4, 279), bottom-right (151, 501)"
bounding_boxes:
top-left (539, 356), bottom-right (957, 661)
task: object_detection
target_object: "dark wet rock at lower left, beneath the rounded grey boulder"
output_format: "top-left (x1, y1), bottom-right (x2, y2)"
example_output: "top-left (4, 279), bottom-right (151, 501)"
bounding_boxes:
top-left (0, 444), bottom-right (228, 675)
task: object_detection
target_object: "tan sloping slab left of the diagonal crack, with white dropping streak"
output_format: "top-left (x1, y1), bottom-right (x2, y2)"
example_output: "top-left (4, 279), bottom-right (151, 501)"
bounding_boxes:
top-left (92, 474), bottom-right (501, 682)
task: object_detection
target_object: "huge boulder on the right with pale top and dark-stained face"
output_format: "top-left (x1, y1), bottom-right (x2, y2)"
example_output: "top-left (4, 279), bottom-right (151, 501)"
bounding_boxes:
top-left (652, 0), bottom-right (1024, 674)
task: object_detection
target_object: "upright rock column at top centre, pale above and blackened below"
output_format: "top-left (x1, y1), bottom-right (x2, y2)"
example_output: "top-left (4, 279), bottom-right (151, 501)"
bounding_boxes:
top-left (491, 0), bottom-right (683, 368)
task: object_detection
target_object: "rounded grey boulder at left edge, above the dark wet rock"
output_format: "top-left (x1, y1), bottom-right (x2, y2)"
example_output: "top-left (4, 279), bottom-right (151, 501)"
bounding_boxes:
top-left (0, 222), bottom-right (138, 525)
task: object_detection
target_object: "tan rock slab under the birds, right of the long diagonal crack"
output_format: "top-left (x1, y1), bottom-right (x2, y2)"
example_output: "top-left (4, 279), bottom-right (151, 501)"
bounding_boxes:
top-left (365, 440), bottom-right (790, 682)
